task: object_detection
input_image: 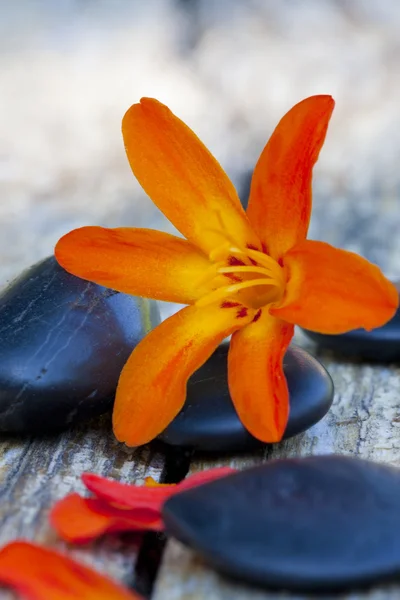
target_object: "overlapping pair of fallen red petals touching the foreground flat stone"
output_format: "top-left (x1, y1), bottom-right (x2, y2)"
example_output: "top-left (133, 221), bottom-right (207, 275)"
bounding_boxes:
top-left (50, 467), bottom-right (234, 544)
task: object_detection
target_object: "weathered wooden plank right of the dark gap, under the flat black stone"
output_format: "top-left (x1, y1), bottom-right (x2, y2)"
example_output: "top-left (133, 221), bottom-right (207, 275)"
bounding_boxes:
top-left (153, 338), bottom-right (400, 600)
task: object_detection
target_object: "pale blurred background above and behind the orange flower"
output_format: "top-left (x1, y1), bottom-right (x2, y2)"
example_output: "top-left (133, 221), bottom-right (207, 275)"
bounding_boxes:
top-left (0, 0), bottom-right (400, 283)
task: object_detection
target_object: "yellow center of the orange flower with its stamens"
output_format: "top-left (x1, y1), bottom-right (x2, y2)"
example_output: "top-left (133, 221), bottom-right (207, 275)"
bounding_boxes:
top-left (196, 243), bottom-right (286, 309)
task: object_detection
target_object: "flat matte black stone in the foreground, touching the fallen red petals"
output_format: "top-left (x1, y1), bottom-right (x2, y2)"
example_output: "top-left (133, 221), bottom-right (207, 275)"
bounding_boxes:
top-left (163, 456), bottom-right (400, 591)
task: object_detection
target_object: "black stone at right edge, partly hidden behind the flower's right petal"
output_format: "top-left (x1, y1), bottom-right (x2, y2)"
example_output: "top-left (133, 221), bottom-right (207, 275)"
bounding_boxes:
top-left (303, 285), bottom-right (400, 362)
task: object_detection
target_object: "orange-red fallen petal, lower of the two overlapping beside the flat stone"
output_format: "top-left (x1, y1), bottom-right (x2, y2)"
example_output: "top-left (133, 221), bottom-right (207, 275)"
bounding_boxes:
top-left (49, 494), bottom-right (164, 544)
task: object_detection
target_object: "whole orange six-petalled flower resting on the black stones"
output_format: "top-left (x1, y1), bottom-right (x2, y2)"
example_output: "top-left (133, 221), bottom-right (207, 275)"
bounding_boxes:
top-left (55, 96), bottom-right (398, 446)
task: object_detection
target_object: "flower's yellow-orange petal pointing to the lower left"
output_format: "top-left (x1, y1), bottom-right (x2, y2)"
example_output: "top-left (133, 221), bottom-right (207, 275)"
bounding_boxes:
top-left (113, 305), bottom-right (252, 446)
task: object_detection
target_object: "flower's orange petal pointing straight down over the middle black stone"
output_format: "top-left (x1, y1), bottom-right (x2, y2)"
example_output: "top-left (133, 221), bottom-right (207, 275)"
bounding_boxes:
top-left (228, 309), bottom-right (294, 442)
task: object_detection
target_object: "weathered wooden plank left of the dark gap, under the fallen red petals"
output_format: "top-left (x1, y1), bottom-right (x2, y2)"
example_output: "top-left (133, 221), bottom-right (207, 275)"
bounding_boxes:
top-left (0, 417), bottom-right (164, 599)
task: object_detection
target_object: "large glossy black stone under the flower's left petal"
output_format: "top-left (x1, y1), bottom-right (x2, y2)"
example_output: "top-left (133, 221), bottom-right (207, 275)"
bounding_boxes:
top-left (0, 257), bottom-right (159, 433)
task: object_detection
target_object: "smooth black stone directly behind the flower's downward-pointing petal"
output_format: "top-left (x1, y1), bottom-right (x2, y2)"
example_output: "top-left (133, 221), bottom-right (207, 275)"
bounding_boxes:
top-left (160, 343), bottom-right (333, 452)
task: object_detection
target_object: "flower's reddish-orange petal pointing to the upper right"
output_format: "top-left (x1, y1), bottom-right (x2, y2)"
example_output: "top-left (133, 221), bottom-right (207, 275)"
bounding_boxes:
top-left (247, 96), bottom-right (334, 260)
